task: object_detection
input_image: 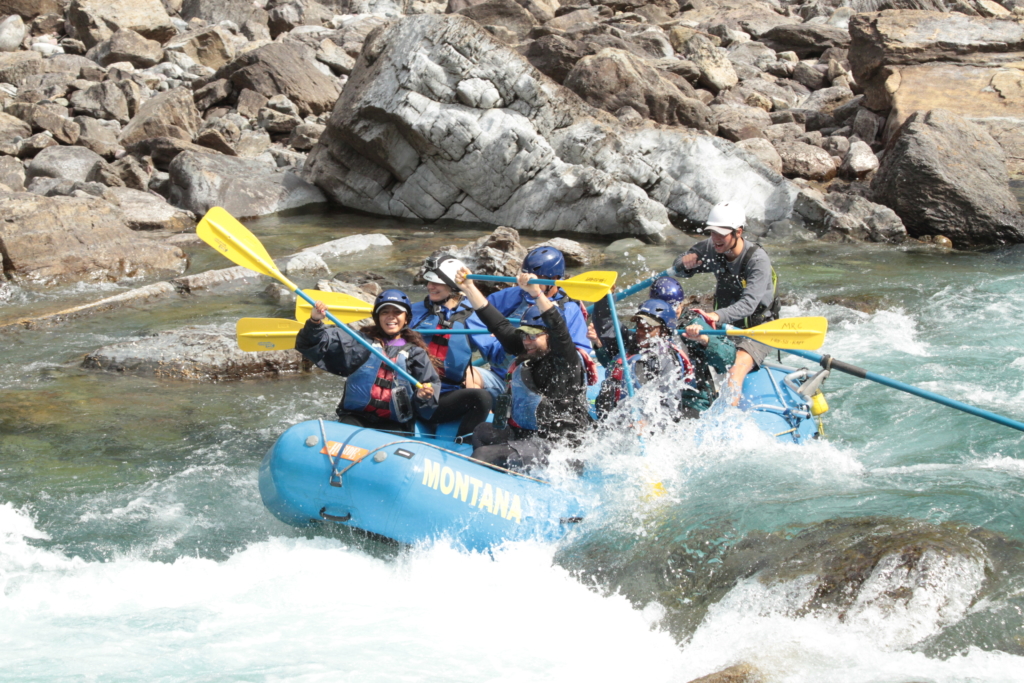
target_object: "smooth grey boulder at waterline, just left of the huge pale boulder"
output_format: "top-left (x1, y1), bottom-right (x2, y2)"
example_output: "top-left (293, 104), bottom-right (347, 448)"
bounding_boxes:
top-left (169, 152), bottom-right (327, 218)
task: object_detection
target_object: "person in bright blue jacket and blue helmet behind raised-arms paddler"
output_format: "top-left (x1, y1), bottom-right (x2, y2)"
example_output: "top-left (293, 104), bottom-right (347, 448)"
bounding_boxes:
top-left (470, 247), bottom-right (593, 378)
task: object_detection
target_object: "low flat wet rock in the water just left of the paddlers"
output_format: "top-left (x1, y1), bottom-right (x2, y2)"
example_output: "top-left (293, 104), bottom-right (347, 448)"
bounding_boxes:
top-left (82, 323), bottom-right (309, 382)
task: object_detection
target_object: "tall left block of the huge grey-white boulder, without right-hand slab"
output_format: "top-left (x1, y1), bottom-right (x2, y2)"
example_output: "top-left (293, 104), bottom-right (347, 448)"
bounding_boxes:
top-left (306, 14), bottom-right (668, 239)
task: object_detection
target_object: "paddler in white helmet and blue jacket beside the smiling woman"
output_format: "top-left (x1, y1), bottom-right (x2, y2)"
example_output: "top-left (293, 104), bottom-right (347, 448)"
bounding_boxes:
top-left (410, 255), bottom-right (500, 436)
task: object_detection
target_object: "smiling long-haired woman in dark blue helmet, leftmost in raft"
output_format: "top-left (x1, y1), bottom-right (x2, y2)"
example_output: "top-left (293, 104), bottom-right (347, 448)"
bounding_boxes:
top-left (295, 290), bottom-right (440, 431)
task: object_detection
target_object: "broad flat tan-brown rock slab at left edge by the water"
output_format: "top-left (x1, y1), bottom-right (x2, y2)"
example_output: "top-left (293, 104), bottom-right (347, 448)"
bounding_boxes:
top-left (0, 192), bottom-right (186, 285)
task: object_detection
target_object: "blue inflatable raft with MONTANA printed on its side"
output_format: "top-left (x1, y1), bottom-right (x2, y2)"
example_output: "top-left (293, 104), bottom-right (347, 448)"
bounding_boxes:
top-left (259, 364), bottom-right (818, 550)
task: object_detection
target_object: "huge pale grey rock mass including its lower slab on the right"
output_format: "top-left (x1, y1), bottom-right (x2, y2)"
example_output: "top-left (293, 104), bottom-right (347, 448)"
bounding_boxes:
top-left (306, 15), bottom-right (796, 242)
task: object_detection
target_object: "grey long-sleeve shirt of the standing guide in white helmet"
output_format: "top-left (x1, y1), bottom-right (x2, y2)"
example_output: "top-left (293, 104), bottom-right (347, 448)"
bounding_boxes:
top-left (674, 239), bottom-right (775, 325)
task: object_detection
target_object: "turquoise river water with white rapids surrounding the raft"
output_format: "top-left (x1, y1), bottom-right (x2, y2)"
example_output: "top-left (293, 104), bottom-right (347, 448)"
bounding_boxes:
top-left (0, 204), bottom-right (1024, 683)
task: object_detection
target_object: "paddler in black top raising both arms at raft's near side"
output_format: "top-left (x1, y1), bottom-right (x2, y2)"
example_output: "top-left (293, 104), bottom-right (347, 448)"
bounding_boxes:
top-left (456, 269), bottom-right (590, 470)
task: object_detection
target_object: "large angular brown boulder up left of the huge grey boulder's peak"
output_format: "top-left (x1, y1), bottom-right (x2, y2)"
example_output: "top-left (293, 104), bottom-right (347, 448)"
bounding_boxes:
top-left (216, 43), bottom-right (341, 117)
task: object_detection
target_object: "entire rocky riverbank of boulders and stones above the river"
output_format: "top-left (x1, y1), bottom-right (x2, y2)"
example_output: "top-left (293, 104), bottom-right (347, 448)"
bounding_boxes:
top-left (0, 0), bottom-right (1024, 285)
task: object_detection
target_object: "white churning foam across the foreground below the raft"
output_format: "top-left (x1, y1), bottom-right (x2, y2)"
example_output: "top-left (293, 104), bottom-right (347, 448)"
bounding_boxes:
top-left (0, 505), bottom-right (682, 681)
